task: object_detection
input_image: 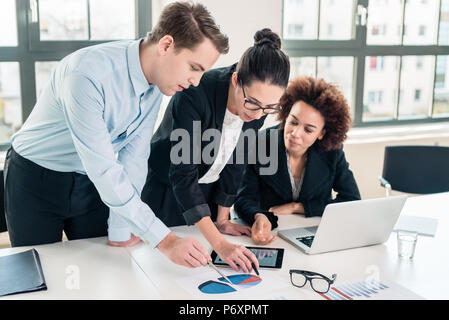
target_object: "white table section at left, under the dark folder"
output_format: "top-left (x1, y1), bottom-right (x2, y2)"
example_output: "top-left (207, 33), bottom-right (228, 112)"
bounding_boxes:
top-left (0, 237), bottom-right (161, 300)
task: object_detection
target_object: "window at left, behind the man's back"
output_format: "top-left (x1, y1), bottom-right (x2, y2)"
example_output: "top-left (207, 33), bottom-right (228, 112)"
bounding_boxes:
top-left (0, 0), bottom-right (151, 143)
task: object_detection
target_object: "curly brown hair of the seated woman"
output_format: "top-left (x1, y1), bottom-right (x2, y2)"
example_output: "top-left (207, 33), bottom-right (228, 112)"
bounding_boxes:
top-left (278, 77), bottom-right (352, 151)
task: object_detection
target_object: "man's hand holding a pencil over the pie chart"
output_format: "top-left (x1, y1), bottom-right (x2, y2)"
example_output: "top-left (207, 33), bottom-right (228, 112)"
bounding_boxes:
top-left (157, 232), bottom-right (212, 268)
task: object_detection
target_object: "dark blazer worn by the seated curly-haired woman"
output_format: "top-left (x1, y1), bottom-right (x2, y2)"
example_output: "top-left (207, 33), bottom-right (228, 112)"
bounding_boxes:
top-left (234, 125), bottom-right (360, 228)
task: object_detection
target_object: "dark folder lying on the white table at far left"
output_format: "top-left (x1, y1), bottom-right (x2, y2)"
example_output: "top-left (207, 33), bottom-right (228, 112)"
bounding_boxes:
top-left (0, 249), bottom-right (47, 296)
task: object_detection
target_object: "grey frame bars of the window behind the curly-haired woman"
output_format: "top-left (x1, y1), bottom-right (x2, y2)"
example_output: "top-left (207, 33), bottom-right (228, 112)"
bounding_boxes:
top-left (282, 0), bottom-right (449, 127)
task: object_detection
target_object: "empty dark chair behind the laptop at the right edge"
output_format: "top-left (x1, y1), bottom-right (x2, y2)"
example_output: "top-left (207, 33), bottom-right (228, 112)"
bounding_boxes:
top-left (379, 146), bottom-right (449, 196)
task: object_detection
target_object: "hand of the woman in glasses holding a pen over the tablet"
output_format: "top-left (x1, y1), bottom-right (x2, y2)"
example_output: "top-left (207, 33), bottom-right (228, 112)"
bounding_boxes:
top-left (214, 241), bottom-right (259, 273)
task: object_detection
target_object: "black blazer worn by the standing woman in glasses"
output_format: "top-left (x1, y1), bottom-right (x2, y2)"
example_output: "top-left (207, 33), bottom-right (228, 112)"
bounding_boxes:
top-left (144, 64), bottom-right (265, 224)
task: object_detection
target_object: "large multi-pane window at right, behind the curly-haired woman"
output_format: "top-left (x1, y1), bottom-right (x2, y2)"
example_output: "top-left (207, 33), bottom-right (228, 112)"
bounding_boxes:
top-left (283, 0), bottom-right (449, 126)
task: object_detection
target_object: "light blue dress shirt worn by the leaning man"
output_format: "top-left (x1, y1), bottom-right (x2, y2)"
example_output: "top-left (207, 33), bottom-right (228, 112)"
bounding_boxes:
top-left (12, 39), bottom-right (170, 247)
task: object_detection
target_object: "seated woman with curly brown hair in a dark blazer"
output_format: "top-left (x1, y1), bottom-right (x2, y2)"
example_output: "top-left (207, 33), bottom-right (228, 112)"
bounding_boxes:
top-left (234, 77), bottom-right (360, 244)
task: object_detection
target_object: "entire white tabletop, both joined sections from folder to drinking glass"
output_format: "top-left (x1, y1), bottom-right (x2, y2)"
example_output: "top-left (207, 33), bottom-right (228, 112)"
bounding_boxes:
top-left (0, 193), bottom-right (449, 299)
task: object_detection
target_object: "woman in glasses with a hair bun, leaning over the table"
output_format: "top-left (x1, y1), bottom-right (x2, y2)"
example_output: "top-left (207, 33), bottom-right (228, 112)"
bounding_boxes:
top-left (133, 29), bottom-right (290, 272)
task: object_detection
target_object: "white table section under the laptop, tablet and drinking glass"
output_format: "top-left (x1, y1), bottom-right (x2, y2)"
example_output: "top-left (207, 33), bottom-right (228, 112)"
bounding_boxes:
top-left (127, 193), bottom-right (449, 299)
